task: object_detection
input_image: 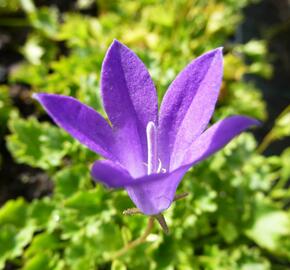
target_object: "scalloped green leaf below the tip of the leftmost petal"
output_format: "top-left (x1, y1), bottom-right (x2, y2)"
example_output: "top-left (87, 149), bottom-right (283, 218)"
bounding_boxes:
top-left (7, 113), bottom-right (72, 169)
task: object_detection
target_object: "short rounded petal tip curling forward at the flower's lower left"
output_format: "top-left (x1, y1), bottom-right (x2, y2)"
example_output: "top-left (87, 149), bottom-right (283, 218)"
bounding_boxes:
top-left (91, 160), bottom-right (134, 188)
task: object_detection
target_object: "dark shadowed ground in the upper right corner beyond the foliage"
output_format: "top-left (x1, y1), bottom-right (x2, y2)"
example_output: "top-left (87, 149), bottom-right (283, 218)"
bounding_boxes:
top-left (241, 0), bottom-right (290, 155)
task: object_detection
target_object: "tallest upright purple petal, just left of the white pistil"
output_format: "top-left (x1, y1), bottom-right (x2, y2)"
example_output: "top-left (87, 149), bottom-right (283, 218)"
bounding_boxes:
top-left (101, 40), bottom-right (158, 176)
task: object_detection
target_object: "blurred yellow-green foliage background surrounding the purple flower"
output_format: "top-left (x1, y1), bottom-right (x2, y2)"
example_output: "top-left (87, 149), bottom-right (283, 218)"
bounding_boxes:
top-left (0, 0), bottom-right (290, 270)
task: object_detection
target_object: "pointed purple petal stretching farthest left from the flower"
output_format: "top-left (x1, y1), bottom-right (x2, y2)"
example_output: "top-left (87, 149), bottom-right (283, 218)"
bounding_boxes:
top-left (33, 94), bottom-right (116, 160)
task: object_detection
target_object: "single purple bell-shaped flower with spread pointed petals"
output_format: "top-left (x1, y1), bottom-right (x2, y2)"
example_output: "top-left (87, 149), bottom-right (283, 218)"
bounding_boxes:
top-left (34, 40), bottom-right (258, 215)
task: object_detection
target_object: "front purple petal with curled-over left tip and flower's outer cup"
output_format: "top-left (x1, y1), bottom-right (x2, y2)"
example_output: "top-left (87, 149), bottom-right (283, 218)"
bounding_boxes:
top-left (91, 160), bottom-right (189, 215)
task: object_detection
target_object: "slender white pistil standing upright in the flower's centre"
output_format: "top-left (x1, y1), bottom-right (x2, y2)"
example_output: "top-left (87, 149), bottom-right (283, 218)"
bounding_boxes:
top-left (146, 122), bottom-right (158, 175)
